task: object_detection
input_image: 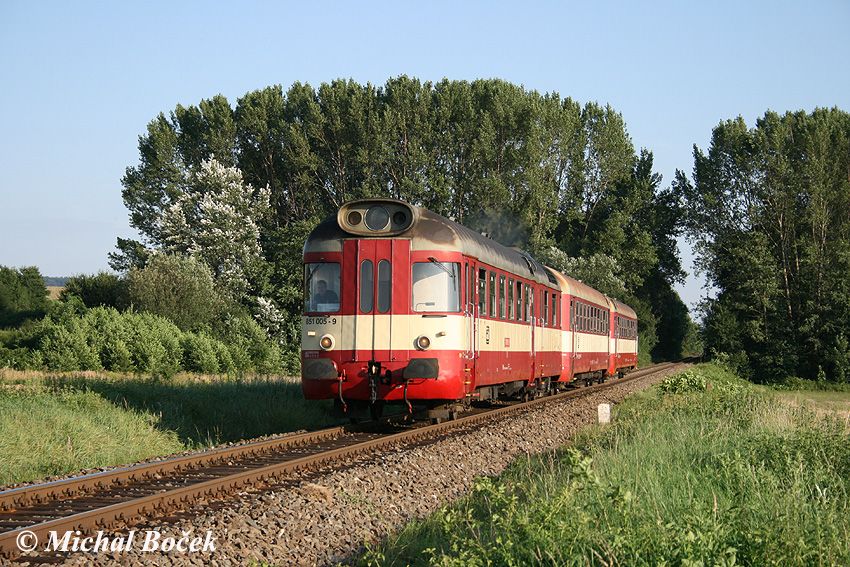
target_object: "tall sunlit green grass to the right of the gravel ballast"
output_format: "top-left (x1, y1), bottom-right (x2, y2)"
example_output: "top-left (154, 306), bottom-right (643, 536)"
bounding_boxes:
top-left (363, 365), bottom-right (850, 565)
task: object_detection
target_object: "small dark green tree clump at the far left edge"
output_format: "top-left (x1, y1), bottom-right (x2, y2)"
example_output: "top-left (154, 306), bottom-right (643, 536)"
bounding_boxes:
top-left (0, 266), bottom-right (48, 328)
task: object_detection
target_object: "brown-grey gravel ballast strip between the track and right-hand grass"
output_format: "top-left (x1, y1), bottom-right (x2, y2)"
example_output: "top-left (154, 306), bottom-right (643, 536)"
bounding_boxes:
top-left (28, 367), bottom-right (681, 567)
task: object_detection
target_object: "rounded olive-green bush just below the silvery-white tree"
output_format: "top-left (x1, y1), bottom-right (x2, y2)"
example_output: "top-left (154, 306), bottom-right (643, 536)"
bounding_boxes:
top-left (128, 254), bottom-right (223, 331)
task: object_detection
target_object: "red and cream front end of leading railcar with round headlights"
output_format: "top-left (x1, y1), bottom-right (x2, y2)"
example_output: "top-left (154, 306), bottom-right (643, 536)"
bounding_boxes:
top-left (301, 199), bottom-right (468, 415)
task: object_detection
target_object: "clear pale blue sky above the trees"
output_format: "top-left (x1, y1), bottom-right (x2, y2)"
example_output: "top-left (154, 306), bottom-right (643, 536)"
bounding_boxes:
top-left (0, 0), bottom-right (850, 310)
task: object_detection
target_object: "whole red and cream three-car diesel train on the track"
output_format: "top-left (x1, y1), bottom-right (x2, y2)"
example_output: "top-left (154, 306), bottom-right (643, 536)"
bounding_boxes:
top-left (301, 199), bottom-right (637, 417)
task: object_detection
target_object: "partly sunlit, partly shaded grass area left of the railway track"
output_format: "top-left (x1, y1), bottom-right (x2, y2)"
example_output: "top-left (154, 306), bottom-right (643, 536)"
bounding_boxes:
top-left (0, 371), bottom-right (338, 484)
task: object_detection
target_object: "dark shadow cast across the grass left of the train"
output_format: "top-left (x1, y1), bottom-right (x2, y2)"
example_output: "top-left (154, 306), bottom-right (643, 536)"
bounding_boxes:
top-left (44, 377), bottom-right (340, 447)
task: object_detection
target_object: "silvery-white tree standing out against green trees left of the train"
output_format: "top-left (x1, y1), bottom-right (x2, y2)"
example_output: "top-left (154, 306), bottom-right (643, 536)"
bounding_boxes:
top-left (159, 158), bottom-right (270, 302)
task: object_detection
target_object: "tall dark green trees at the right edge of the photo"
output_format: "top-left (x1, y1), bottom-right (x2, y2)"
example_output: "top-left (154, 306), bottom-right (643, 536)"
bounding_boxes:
top-left (675, 109), bottom-right (850, 381)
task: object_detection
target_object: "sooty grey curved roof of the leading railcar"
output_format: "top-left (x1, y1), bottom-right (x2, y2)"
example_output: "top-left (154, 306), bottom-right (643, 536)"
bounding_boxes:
top-left (304, 199), bottom-right (559, 288)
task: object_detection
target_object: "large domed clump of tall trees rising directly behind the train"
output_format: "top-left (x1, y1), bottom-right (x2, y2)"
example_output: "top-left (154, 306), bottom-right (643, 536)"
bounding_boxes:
top-left (111, 76), bottom-right (689, 364)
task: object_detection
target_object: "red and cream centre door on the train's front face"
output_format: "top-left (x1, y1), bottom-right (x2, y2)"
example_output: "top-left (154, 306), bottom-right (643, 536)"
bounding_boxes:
top-left (354, 238), bottom-right (410, 362)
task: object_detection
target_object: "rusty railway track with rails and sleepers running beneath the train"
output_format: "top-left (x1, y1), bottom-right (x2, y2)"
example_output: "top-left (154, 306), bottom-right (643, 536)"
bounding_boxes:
top-left (0, 363), bottom-right (679, 560)
